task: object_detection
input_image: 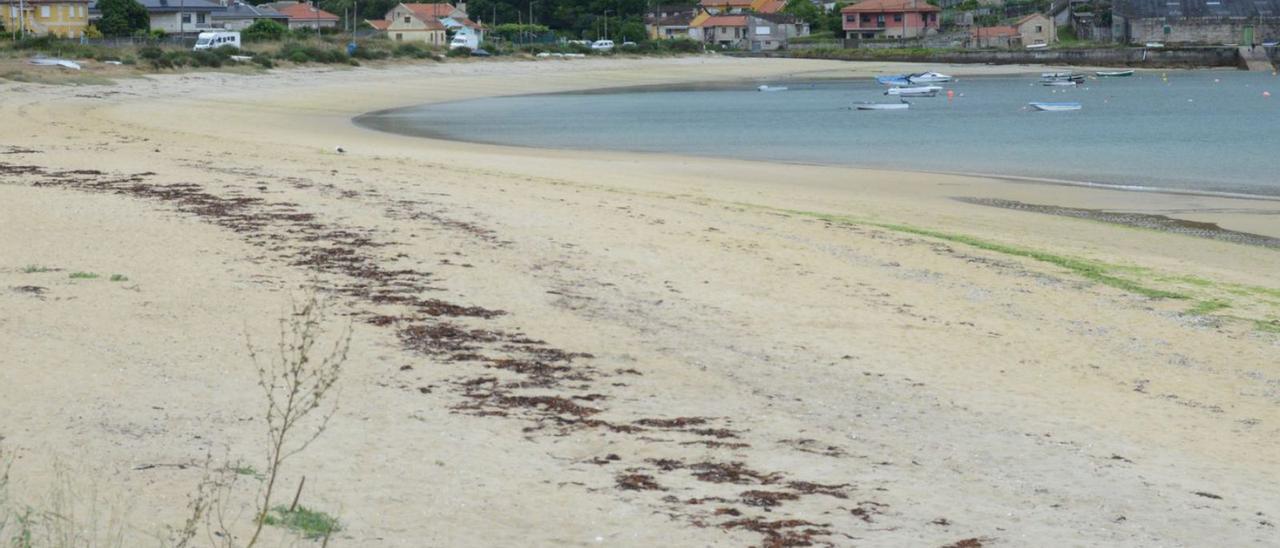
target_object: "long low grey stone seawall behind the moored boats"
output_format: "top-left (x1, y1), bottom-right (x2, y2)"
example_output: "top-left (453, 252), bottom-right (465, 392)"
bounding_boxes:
top-left (754, 47), bottom-right (1240, 68)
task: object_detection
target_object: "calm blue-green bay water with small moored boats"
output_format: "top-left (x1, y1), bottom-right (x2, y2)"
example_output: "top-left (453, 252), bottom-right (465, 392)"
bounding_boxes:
top-left (357, 70), bottom-right (1280, 196)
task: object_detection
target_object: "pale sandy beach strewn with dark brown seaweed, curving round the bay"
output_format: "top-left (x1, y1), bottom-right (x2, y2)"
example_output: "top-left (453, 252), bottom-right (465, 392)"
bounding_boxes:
top-left (0, 58), bottom-right (1280, 547)
